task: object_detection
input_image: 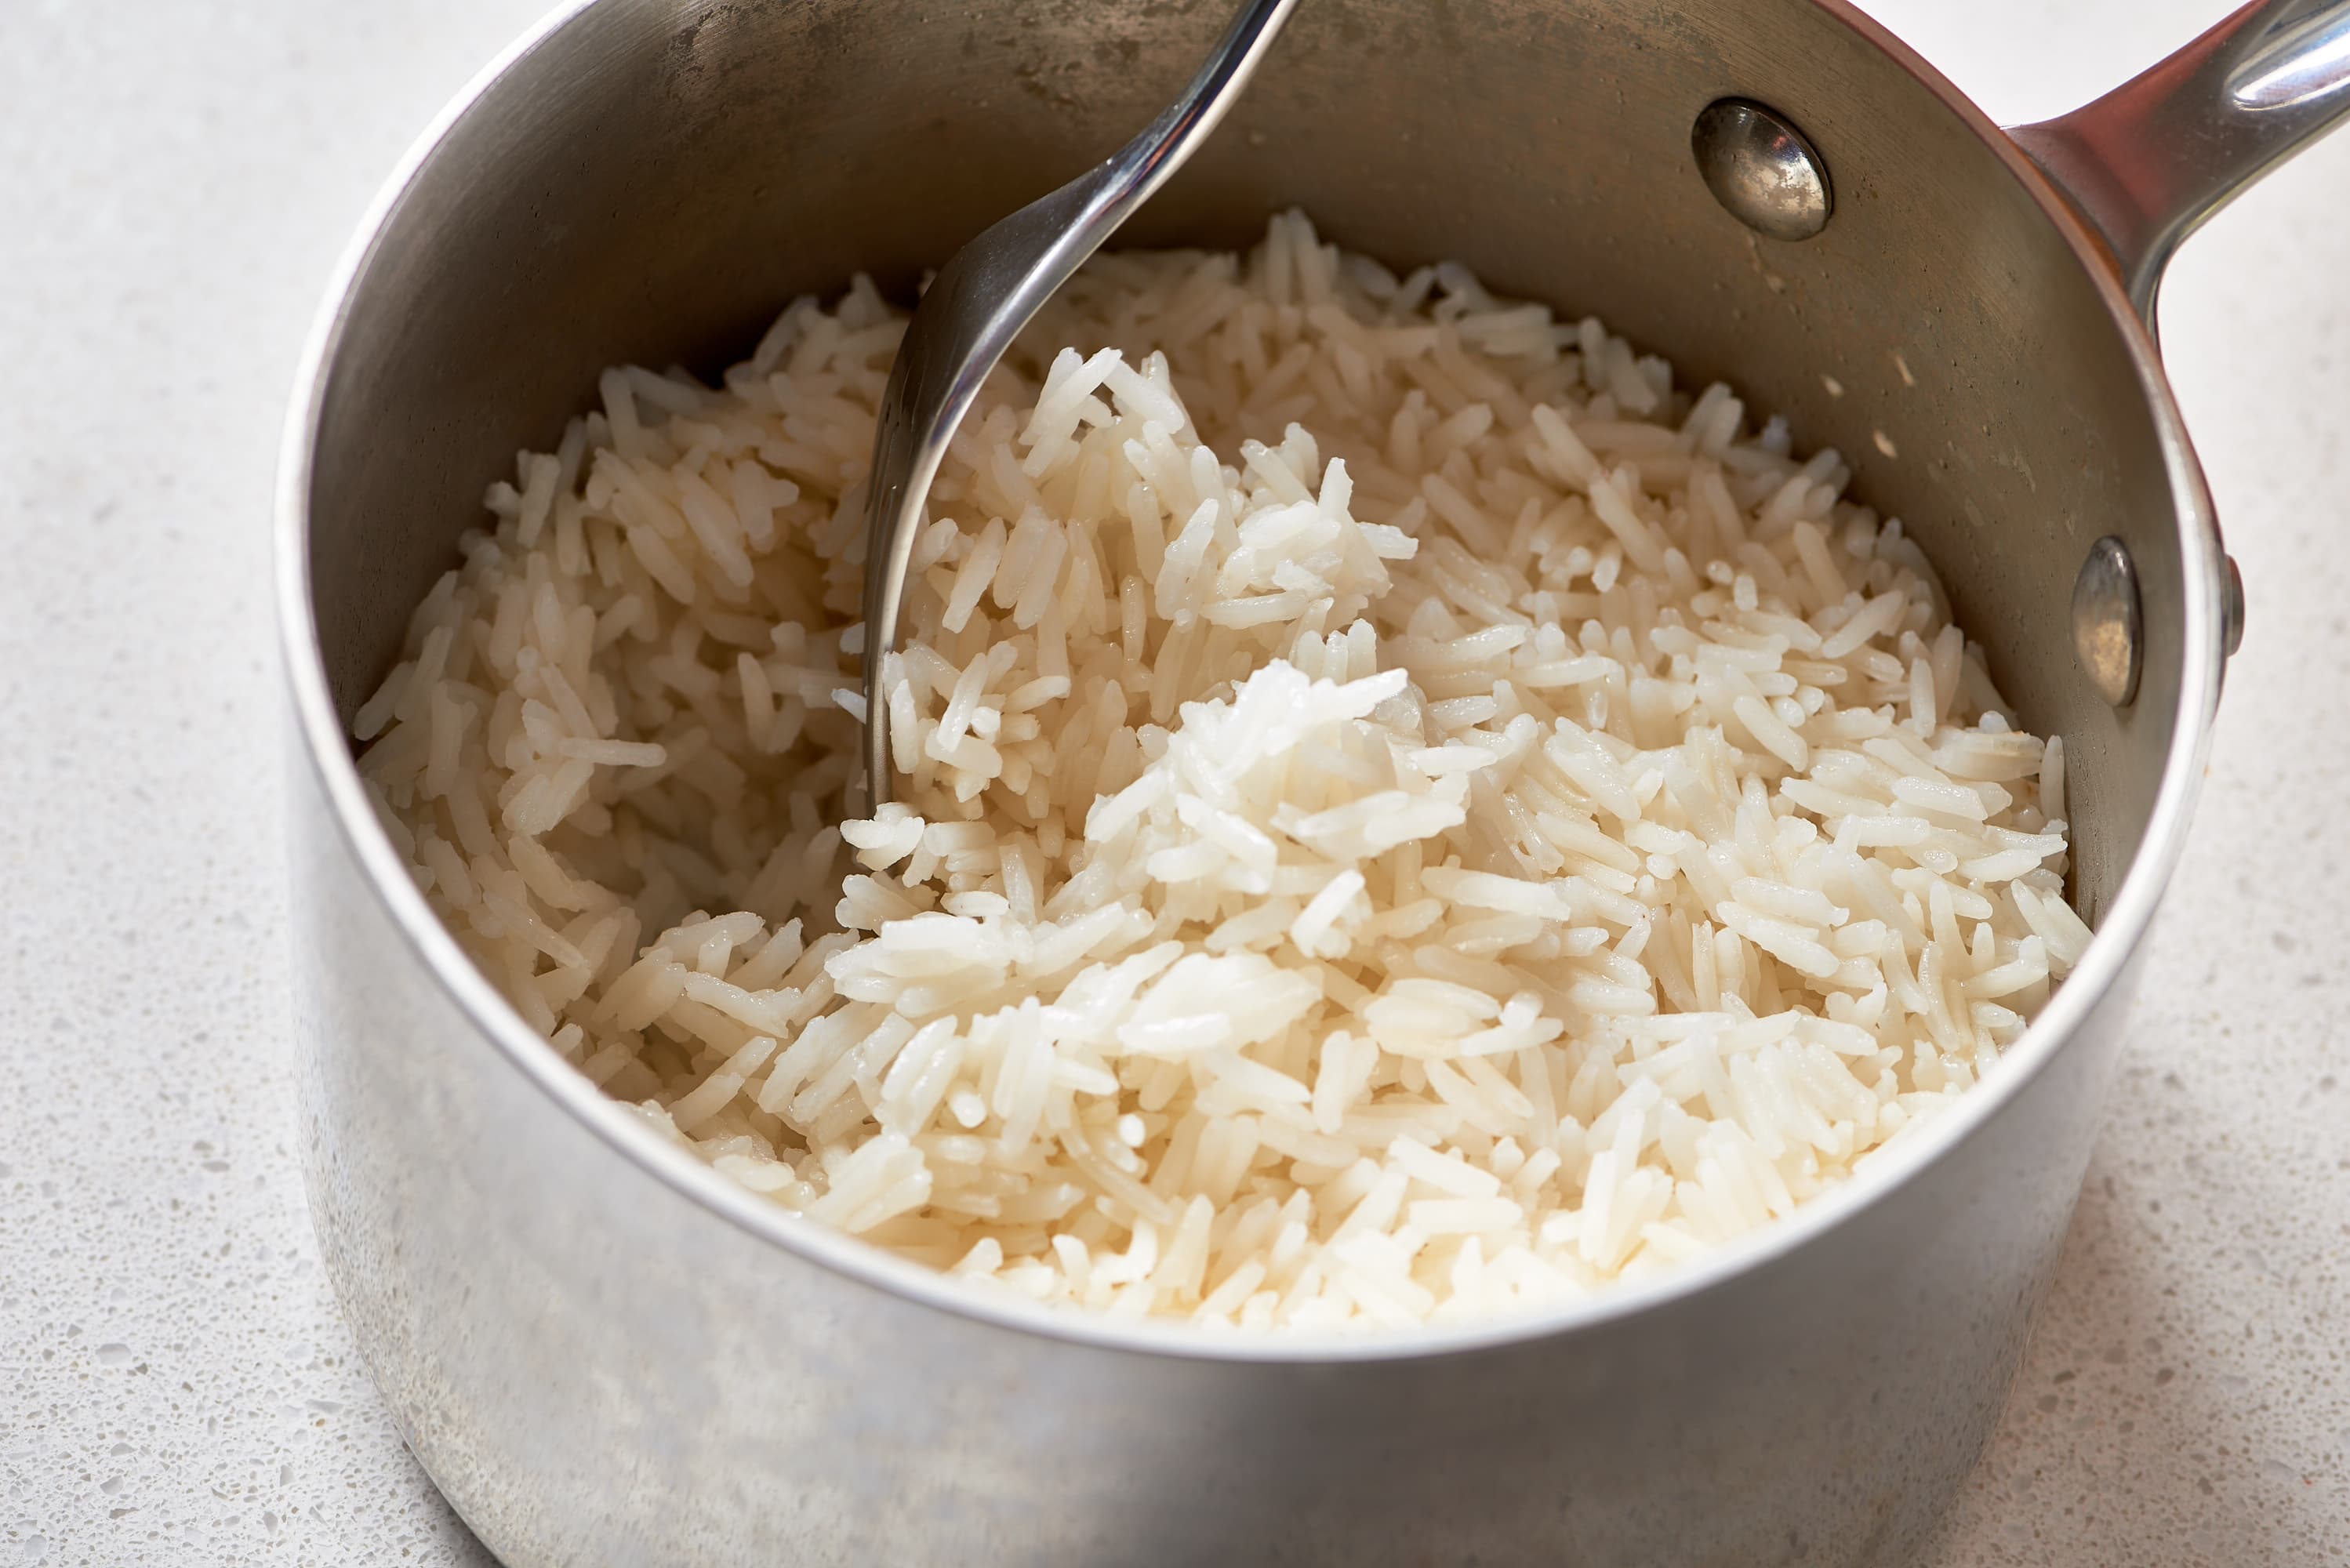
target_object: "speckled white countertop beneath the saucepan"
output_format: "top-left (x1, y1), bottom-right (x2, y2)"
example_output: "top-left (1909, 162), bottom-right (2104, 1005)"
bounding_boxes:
top-left (0, 0), bottom-right (2350, 1568)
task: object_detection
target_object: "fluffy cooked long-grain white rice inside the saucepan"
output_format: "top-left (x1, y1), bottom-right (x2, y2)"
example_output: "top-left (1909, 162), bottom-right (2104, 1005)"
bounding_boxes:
top-left (355, 216), bottom-right (2089, 1326)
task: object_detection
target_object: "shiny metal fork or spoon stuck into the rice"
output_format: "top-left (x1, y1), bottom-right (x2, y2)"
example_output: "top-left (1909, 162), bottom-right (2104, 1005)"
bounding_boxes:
top-left (865, 0), bottom-right (1297, 806)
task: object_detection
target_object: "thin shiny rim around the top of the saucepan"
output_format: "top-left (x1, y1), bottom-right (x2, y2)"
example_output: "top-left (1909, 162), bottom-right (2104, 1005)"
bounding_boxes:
top-left (275, 0), bottom-right (2223, 1363)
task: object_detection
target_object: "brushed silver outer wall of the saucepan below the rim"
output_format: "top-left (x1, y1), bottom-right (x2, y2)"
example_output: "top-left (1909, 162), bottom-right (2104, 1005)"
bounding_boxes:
top-left (292, 742), bottom-right (2134, 1568)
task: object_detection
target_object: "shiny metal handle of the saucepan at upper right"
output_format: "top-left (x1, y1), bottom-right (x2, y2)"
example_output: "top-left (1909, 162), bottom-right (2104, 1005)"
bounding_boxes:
top-left (2009, 0), bottom-right (2350, 332)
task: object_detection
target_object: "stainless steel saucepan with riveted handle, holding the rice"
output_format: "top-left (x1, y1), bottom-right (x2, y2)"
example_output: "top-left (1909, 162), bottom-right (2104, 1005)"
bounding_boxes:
top-left (280, 0), bottom-right (2350, 1568)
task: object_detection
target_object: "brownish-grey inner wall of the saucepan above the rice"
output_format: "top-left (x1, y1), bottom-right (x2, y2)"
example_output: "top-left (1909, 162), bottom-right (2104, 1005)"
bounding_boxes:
top-left (311, 0), bottom-right (2183, 916)
